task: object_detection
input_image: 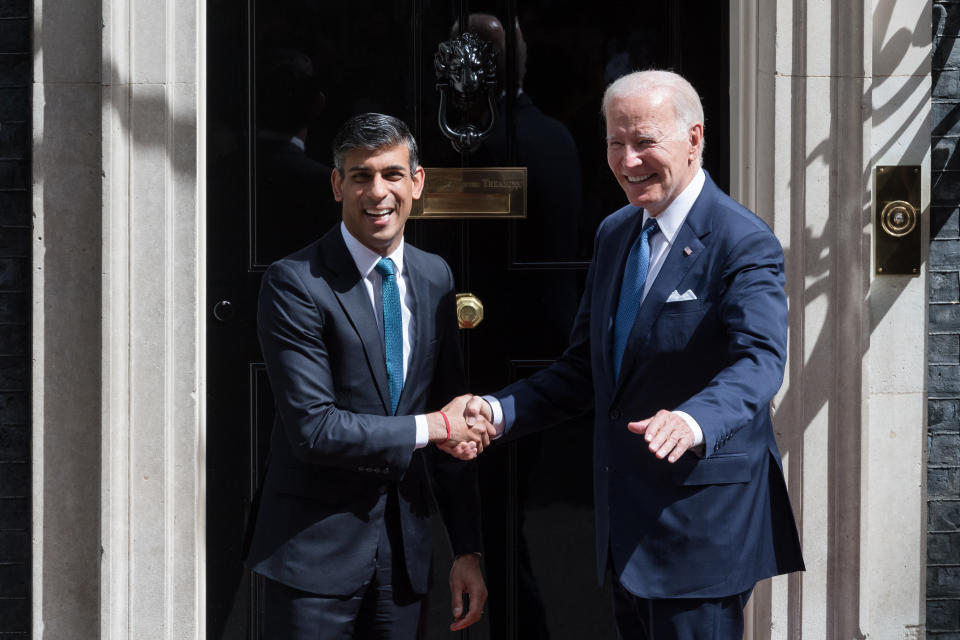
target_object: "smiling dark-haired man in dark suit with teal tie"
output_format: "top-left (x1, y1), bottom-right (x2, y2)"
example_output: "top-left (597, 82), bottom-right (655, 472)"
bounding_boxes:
top-left (248, 114), bottom-right (492, 640)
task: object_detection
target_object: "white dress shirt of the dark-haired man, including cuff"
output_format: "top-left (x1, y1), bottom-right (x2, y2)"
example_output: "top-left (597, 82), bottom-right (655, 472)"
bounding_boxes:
top-left (340, 222), bottom-right (430, 449)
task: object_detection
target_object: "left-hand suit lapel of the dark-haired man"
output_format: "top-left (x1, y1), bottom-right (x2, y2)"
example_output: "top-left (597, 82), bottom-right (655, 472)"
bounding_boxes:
top-left (319, 232), bottom-right (390, 414)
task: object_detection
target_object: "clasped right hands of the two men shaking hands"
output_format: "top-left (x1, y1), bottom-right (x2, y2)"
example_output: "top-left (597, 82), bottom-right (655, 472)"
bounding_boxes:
top-left (427, 394), bottom-right (497, 460)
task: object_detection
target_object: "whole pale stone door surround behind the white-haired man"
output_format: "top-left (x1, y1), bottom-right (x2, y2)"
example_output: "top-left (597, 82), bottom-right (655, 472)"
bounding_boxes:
top-left (732, 0), bottom-right (931, 640)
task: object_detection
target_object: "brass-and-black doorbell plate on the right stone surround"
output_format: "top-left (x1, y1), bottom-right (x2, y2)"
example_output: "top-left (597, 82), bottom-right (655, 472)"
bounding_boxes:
top-left (873, 165), bottom-right (922, 275)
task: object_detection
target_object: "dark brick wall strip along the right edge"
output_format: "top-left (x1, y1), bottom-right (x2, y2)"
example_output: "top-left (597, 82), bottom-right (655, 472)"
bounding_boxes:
top-left (927, 0), bottom-right (960, 640)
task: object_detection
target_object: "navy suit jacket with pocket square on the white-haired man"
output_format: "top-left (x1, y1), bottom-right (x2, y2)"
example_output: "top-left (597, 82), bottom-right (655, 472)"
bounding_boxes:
top-left (494, 176), bottom-right (803, 598)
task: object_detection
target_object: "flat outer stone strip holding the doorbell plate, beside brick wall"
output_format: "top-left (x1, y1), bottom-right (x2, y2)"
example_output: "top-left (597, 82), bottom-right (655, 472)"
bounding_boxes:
top-left (860, 0), bottom-right (933, 638)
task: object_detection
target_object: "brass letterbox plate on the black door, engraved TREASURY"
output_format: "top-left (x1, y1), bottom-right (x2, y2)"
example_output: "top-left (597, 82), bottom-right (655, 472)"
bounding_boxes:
top-left (410, 167), bottom-right (527, 220)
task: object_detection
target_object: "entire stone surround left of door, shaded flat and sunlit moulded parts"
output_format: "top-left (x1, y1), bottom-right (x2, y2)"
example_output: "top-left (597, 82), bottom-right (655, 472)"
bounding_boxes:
top-left (33, 0), bottom-right (205, 640)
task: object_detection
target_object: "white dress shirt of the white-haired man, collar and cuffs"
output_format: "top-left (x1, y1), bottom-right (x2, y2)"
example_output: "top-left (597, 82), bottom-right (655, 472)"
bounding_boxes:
top-left (483, 169), bottom-right (706, 456)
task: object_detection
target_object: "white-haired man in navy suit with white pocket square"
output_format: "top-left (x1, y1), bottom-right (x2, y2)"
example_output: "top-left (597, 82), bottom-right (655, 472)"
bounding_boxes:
top-left (467, 71), bottom-right (803, 640)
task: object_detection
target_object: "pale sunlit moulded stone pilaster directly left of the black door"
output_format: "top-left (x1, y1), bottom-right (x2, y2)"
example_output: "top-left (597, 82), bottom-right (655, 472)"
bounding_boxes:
top-left (100, 0), bottom-right (205, 640)
